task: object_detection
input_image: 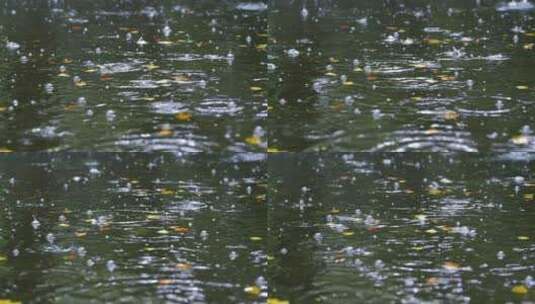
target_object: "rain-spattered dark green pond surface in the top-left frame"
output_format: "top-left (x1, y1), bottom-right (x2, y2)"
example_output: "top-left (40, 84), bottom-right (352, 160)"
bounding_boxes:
top-left (0, 0), bottom-right (267, 152)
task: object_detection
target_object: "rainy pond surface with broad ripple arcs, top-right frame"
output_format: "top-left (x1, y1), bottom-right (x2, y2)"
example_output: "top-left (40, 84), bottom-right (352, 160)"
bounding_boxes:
top-left (268, 0), bottom-right (535, 152)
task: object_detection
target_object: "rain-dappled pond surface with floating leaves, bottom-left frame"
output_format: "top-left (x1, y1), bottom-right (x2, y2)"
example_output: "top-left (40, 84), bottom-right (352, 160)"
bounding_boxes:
top-left (0, 154), bottom-right (267, 303)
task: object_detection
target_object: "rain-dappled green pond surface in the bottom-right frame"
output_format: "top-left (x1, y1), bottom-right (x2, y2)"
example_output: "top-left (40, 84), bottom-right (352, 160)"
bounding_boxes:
top-left (268, 154), bottom-right (535, 303)
